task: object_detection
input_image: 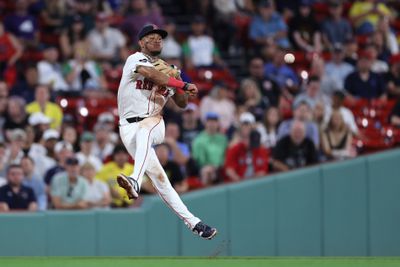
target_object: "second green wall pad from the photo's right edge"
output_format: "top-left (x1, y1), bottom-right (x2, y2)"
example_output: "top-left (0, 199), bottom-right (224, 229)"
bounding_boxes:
top-left (322, 158), bottom-right (368, 256)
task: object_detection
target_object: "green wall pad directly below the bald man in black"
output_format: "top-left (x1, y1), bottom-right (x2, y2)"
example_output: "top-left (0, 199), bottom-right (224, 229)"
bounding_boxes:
top-left (276, 168), bottom-right (322, 256)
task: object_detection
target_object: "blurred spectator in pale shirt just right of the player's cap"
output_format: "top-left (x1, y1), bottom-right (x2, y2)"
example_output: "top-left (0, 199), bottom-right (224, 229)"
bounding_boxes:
top-left (160, 19), bottom-right (182, 60)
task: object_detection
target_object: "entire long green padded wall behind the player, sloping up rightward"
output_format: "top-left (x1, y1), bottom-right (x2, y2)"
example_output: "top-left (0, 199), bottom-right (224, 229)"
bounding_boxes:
top-left (0, 149), bottom-right (400, 257)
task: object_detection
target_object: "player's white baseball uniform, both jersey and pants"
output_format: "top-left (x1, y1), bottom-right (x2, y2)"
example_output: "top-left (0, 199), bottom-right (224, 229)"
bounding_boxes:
top-left (118, 52), bottom-right (200, 229)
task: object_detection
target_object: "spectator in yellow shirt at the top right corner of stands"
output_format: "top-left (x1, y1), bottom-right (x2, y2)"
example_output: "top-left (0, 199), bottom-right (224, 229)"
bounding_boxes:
top-left (349, 0), bottom-right (391, 34)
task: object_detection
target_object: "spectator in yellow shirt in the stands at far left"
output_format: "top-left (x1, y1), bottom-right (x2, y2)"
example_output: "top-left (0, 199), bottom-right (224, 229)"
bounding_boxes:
top-left (26, 85), bottom-right (63, 129)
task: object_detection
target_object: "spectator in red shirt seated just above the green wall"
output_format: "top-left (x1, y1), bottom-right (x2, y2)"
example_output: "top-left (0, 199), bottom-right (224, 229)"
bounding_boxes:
top-left (224, 130), bottom-right (269, 182)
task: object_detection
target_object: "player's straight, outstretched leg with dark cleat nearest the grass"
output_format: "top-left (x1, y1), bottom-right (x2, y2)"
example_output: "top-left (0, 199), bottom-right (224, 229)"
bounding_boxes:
top-left (146, 148), bottom-right (217, 239)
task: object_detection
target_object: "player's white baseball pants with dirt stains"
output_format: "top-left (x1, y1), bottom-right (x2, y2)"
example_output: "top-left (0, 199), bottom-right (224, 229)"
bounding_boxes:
top-left (119, 116), bottom-right (200, 229)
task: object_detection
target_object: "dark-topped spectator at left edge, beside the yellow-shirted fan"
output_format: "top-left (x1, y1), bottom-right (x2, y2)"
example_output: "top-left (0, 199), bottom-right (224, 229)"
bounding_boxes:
top-left (3, 96), bottom-right (28, 133)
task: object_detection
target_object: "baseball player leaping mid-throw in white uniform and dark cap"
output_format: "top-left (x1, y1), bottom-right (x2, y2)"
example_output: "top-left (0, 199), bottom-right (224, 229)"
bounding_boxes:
top-left (117, 25), bottom-right (217, 239)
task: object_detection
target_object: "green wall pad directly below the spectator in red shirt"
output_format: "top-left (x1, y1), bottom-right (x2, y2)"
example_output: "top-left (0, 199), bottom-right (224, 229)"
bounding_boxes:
top-left (229, 178), bottom-right (276, 256)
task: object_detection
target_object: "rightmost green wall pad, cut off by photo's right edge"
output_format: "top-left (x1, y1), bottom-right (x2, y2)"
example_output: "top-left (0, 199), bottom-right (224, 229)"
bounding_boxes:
top-left (368, 150), bottom-right (400, 256)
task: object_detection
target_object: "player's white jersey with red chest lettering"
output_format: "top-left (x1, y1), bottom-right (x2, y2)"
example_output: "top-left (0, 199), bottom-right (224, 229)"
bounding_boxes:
top-left (118, 52), bottom-right (174, 124)
